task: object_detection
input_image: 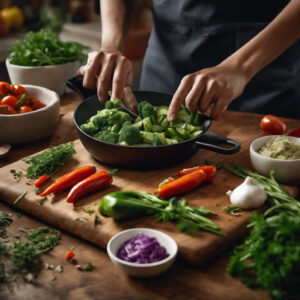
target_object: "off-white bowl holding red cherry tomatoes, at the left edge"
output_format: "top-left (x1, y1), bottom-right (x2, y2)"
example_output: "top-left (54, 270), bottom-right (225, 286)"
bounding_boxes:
top-left (0, 84), bottom-right (60, 145)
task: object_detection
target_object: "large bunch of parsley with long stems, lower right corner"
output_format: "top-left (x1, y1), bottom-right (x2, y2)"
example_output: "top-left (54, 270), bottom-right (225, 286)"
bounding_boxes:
top-left (206, 161), bottom-right (300, 299)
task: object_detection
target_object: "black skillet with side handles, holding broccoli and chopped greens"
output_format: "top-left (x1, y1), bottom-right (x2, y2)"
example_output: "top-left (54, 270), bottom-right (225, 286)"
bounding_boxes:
top-left (67, 76), bottom-right (241, 169)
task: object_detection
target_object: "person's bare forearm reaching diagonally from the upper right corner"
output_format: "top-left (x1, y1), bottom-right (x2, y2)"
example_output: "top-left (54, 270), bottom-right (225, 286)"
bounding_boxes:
top-left (223, 0), bottom-right (300, 80)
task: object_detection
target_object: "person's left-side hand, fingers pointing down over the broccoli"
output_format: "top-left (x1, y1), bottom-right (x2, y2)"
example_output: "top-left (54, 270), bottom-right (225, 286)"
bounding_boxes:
top-left (77, 50), bottom-right (137, 111)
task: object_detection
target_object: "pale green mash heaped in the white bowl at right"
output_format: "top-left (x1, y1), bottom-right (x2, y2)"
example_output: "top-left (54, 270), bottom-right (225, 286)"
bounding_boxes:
top-left (258, 136), bottom-right (300, 160)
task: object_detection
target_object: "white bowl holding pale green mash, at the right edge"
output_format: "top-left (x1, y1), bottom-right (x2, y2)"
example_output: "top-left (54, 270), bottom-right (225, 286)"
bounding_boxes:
top-left (250, 135), bottom-right (300, 183)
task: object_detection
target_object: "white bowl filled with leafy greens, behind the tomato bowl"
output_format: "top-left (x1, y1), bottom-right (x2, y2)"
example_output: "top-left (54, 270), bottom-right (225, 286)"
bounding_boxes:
top-left (6, 59), bottom-right (80, 95)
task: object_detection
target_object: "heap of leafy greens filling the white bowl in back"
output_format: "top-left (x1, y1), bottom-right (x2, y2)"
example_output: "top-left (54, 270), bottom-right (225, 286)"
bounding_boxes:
top-left (8, 30), bottom-right (88, 66)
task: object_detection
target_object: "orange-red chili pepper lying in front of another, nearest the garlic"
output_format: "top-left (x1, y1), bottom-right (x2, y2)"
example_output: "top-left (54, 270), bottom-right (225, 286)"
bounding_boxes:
top-left (157, 170), bottom-right (206, 199)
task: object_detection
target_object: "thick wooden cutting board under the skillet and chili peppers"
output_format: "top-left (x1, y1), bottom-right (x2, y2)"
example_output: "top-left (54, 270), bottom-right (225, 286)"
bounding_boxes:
top-left (0, 137), bottom-right (293, 264)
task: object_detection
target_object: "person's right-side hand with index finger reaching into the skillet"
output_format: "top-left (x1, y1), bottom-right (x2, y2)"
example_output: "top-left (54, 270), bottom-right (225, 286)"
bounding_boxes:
top-left (168, 63), bottom-right (248, 121)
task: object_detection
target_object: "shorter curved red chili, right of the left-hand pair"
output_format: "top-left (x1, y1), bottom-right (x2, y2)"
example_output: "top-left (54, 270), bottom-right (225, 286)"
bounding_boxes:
top-left (67, 170), bottom-right (112, 203)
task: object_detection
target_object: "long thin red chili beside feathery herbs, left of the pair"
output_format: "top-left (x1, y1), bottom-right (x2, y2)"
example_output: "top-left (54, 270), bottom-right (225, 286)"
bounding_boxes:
top-left (40, 166), bottom-right (96, 197)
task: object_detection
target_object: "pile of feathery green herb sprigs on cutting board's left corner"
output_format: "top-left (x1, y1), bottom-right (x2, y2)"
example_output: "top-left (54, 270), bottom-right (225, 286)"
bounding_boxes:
top-left (23, 143), bottom-right (76, 179)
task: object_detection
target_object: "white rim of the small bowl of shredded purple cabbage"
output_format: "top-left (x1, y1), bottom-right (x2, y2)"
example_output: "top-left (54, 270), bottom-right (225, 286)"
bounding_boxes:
top-left (107, 228), bottom-right (178, 268)
